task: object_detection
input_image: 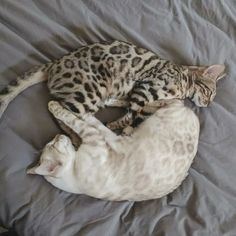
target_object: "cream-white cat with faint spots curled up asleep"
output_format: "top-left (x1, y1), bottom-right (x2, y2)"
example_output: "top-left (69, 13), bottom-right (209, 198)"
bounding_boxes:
top-left (27, 100), bottom-right (199, 201)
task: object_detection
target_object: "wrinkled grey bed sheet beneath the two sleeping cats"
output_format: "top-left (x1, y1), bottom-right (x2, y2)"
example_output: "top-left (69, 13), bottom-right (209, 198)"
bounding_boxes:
top-left (0, 0), bottom-right (236, 236)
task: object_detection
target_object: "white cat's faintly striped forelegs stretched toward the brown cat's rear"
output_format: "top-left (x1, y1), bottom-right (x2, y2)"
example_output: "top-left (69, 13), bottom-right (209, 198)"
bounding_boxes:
top-left (48, 101), bottom-right (117, 143)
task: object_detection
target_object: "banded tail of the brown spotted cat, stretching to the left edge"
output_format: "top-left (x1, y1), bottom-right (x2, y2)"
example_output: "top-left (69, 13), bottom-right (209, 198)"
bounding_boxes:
top-left (0, 62), bottom-right (52, 118)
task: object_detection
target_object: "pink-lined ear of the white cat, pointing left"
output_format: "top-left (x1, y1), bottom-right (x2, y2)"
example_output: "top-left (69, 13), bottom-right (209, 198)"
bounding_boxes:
top-left (26, 160), bottom-right (62, 176)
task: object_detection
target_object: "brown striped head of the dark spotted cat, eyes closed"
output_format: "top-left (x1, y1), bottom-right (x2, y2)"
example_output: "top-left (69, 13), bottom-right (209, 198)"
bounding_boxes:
top-left (184, 65), bottom-right (226, 107)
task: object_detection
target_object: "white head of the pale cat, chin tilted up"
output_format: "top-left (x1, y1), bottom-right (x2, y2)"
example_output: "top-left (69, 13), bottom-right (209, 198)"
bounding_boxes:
top-left (27, 135), bottom-right (75, 177)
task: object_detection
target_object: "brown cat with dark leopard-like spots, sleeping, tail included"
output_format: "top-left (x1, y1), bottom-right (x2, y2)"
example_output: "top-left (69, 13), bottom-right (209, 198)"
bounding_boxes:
top-left (0, 41), bottom-right (225, 129)
